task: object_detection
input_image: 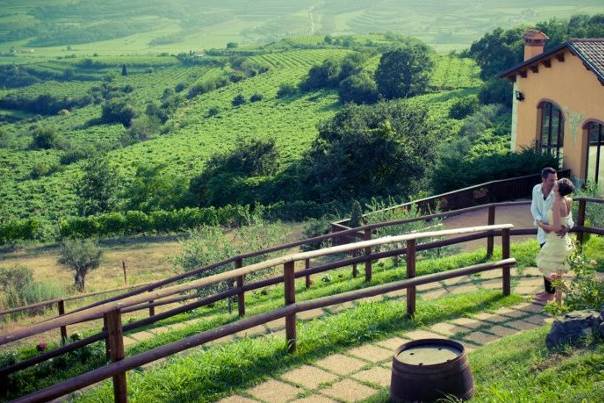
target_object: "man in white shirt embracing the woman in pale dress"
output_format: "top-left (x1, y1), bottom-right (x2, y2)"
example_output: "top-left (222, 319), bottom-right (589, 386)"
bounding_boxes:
top-left (531, 167), bottom-right (574, 300)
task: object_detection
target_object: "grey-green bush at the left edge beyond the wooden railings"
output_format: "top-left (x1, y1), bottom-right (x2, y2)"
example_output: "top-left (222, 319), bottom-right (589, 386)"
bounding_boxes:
top-left (0, 266), bottom-right (64, 318)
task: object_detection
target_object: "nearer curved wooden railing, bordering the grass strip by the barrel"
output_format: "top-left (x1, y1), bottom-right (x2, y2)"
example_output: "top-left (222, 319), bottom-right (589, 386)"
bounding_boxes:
top-left (8, 224), bottom-right (516, 402)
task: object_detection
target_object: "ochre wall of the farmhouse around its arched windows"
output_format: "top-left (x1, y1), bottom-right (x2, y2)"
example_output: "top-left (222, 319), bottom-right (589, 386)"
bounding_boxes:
top-left (514, 51), bottom-right (604, 180)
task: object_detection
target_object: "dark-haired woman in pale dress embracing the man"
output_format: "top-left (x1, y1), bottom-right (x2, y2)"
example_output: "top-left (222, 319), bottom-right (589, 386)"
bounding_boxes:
top-left (537, 178), bottom-right (575, 303)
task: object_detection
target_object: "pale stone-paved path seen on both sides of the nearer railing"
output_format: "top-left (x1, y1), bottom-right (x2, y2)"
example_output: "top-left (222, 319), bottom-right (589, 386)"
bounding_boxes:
top-left (118, 268), bottom-right (548, 403)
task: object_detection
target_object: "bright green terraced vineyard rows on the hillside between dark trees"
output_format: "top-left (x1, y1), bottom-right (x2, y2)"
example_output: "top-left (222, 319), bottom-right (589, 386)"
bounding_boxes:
top-left (0, 49), bottom-right (480, 224)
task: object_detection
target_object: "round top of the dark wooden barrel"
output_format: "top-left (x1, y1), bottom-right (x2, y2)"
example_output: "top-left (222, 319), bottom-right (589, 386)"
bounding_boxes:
top-left (396, 339), bottom-right (463, 366)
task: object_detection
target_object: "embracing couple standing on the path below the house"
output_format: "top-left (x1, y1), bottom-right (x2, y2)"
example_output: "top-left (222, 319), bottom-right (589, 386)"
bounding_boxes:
top-left (531, 168), bottom-right (575, 302)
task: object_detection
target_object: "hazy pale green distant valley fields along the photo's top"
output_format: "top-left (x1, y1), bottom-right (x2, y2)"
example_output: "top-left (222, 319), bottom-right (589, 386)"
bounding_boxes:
top-left (0, 0), bottom-right (604, 57)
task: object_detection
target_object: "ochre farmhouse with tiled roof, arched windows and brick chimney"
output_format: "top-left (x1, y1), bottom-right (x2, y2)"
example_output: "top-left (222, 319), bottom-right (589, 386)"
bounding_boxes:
top-left (501, 30), bottom-right (604, 189)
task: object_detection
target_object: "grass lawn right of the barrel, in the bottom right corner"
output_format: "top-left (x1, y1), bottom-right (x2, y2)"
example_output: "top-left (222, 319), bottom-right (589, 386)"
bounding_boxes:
top-left (367, 326), bottom-right (604, 403)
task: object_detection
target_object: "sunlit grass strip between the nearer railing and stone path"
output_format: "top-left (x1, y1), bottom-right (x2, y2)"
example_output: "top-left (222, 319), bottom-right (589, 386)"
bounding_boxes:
top-left (78, 290), bottom-right (522, 402)
